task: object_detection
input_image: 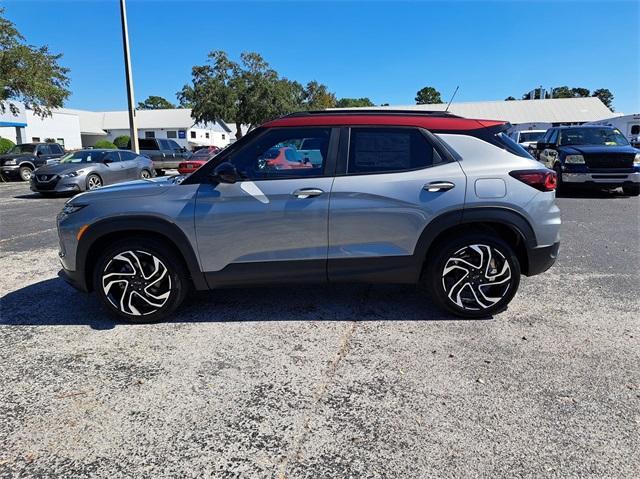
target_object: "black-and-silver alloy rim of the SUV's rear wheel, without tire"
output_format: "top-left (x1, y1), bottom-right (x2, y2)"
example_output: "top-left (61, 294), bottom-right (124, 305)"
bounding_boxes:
top-left (442, 244), bottom-right (512, 311)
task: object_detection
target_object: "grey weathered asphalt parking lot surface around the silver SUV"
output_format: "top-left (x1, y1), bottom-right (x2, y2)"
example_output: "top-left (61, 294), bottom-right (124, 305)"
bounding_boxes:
top-left (0, 183), bottom-right (640, 478)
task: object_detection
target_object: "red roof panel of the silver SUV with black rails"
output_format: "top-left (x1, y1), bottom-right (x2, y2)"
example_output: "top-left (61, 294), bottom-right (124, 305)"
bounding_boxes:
top-left (263, 110), bottom-right (506, 131)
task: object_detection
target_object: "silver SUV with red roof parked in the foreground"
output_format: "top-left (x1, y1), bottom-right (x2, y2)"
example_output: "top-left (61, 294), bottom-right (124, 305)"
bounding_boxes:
top-left (58, 110), bottom-right (560, 322)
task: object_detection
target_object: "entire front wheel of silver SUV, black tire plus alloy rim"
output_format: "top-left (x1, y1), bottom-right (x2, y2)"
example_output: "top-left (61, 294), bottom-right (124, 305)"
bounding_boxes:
top-left (93, 237), bottom-right (190, 323)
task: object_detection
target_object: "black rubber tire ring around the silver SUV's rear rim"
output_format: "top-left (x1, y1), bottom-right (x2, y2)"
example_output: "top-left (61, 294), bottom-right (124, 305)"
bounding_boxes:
top-left (426, 234), bottom-right (521, 318)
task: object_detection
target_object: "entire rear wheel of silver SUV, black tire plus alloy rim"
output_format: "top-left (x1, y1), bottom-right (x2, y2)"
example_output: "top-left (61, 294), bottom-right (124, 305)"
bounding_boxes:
top-left (423, 233), bottom-right (520, 318)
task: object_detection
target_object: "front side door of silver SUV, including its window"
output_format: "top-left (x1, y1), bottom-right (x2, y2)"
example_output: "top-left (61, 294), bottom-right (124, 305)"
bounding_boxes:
top-left (195, 127), bottom-right (338, 287)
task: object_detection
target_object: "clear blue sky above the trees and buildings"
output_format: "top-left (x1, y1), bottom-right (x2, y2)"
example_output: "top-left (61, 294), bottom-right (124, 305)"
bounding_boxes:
top-left (2, 0), bottom-right (640, 113)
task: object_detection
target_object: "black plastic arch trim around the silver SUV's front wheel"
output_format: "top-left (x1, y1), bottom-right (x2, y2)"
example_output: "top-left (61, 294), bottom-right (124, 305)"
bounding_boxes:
top-left (76, 216), bottom-right (208, 291)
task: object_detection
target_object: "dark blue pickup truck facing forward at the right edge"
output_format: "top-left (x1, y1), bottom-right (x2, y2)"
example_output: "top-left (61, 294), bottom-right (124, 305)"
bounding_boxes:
top-left (537, 125), bottom-right (640, 196)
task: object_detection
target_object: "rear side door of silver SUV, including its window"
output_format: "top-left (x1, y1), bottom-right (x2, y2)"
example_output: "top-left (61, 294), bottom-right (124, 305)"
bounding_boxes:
top-left (328, 127), bottom-right (466, 282)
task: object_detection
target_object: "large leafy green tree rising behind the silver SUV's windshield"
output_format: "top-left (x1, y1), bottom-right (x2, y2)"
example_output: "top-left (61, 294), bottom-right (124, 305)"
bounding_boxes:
top-left (178, 50), bottom-right (305, 138)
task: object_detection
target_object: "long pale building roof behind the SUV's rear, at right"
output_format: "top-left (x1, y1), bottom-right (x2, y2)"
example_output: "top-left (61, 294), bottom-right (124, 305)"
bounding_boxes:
top-left (348, 97), bottom-right (614, 124)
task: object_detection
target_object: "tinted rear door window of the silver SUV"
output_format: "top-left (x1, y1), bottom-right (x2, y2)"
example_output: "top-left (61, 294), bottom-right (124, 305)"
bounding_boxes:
top-left (347, 128), bottom-right (434, 175)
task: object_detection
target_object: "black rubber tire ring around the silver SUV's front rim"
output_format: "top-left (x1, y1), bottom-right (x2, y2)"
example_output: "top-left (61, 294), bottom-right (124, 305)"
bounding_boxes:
top-left (93, 238), bottom-right (189, 324)
